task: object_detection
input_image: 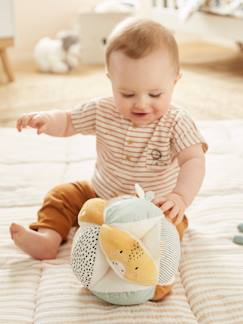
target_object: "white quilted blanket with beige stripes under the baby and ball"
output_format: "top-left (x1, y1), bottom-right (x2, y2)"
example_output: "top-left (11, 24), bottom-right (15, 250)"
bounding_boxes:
top-left (0, 121), bottom-right (243, 324)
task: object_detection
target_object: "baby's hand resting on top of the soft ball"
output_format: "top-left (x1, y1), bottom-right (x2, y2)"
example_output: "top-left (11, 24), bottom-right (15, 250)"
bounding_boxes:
top-left (153, 192), bottom-right (186, 225)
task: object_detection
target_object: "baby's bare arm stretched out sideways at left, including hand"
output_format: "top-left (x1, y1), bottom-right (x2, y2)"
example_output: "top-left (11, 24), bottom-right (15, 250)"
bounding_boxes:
top-left (16, 110), bottom-right (75, 137)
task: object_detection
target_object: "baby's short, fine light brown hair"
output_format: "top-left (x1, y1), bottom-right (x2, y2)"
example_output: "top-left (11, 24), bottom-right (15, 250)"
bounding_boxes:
top-left (106, 18), bottom-right (180, 74)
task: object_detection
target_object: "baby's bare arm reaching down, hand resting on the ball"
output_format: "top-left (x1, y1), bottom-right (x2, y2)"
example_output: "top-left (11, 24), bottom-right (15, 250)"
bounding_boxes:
top-left (154, 144), bottom-right (205, 225)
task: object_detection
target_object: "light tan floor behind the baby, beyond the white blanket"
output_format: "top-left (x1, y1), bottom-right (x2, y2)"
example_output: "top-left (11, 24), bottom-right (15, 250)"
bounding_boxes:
top-left (0, 42), bottom-right (243, 127)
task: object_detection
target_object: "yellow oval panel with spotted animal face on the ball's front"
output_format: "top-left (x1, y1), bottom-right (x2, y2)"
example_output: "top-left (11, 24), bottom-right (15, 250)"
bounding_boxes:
top-left (99, 224), bottom-right (159, 286)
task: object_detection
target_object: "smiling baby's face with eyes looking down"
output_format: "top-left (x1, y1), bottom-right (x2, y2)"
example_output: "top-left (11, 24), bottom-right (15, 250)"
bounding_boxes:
top-left (108, 50), bottom-right (179, 127)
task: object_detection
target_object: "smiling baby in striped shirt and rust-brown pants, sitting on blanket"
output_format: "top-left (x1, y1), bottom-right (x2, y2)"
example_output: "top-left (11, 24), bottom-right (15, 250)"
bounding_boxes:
top-left (10, 18), bottom-right (207, 260)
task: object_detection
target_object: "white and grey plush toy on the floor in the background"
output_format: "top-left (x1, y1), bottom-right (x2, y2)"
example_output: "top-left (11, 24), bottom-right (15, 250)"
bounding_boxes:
top-left (34, 31), bottom-right (81, 73)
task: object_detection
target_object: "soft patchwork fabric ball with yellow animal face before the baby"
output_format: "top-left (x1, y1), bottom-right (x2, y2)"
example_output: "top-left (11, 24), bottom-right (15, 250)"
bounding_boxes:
top-left (71, 186), bottom-right (180, 305)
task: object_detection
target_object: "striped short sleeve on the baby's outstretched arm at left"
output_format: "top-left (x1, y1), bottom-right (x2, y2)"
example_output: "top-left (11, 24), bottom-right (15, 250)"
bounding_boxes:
top-left (71, 99), bottom-right (98, 135)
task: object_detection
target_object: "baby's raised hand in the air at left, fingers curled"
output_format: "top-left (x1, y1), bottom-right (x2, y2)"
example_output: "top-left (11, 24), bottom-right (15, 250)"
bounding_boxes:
top-left (16, 112), bottom-right (49, 135)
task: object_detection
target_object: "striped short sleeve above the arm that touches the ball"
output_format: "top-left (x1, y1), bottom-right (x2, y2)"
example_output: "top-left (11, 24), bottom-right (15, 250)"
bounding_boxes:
top-left (173, 112), bottom-right (208, 153)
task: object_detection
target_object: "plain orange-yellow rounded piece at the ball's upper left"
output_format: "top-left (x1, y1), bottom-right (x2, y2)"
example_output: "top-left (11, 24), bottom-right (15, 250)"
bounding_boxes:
top-left (78, 198), bottom-right (107, 225)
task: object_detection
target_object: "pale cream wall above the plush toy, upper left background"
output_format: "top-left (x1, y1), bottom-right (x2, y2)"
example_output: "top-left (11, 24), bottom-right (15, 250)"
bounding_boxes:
top-left (9, 0), bottom-right (100, 64)
